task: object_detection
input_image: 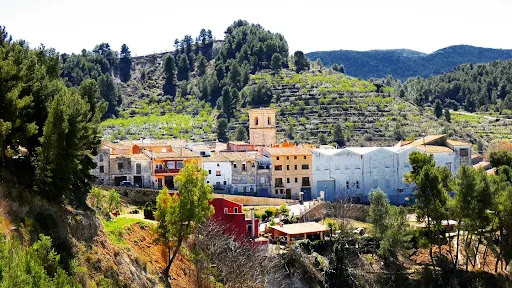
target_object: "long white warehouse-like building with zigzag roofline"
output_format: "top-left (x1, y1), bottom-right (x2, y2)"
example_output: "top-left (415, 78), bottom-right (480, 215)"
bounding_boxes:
top-left (312, 135), bottom-right (471, 204)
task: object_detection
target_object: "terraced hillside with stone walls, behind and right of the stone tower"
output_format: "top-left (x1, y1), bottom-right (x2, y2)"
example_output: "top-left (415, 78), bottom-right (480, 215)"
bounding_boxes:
top-left (235, 70), bottom-right (512, 147)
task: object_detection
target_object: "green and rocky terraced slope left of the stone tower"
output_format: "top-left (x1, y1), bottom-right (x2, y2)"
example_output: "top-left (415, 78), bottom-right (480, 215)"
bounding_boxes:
top-left (101, 51), bottom-right (216, 141)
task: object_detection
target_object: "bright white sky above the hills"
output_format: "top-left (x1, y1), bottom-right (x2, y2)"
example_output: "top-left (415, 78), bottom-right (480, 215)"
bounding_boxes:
top-left (0, 0), bottom-right (512, 56)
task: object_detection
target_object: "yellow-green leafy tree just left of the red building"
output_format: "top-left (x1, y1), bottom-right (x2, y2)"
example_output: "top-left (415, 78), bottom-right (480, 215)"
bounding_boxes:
top-left (155, 162), bottom-right (213, 287)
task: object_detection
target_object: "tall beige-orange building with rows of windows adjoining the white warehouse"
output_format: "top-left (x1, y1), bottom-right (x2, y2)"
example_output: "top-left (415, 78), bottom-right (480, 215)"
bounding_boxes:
top-left (263, 146), bottom-right (313, 199)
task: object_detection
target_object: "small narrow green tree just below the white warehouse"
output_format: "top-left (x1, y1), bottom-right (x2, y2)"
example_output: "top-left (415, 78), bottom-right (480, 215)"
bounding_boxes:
top-left (368, 188), bottom-right (390, 239)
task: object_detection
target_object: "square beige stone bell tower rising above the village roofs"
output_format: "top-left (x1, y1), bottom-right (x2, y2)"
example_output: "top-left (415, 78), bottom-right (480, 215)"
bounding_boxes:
top-left (249, 108), bottom-right (276, 147)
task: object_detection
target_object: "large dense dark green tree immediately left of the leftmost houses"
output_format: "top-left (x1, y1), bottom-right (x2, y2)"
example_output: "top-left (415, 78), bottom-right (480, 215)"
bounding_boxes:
top-left (34, 84), bottom-right (103, 205)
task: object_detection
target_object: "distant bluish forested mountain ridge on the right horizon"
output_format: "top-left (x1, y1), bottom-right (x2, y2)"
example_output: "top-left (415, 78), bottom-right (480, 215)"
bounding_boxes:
top-left (306, 45), bottom-right (512, 81)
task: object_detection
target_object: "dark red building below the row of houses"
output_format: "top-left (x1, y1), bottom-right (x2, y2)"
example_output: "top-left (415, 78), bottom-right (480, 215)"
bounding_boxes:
top-left (210, 198), bottom-right (259, 238)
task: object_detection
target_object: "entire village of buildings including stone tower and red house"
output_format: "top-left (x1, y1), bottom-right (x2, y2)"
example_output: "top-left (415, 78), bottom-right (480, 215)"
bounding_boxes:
top-left (93, 108), bottom-right (493, 245)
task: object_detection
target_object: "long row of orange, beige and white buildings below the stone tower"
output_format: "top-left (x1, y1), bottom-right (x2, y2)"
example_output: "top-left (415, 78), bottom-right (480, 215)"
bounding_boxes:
top-left (93, 135), bottom-right (471, 203)
